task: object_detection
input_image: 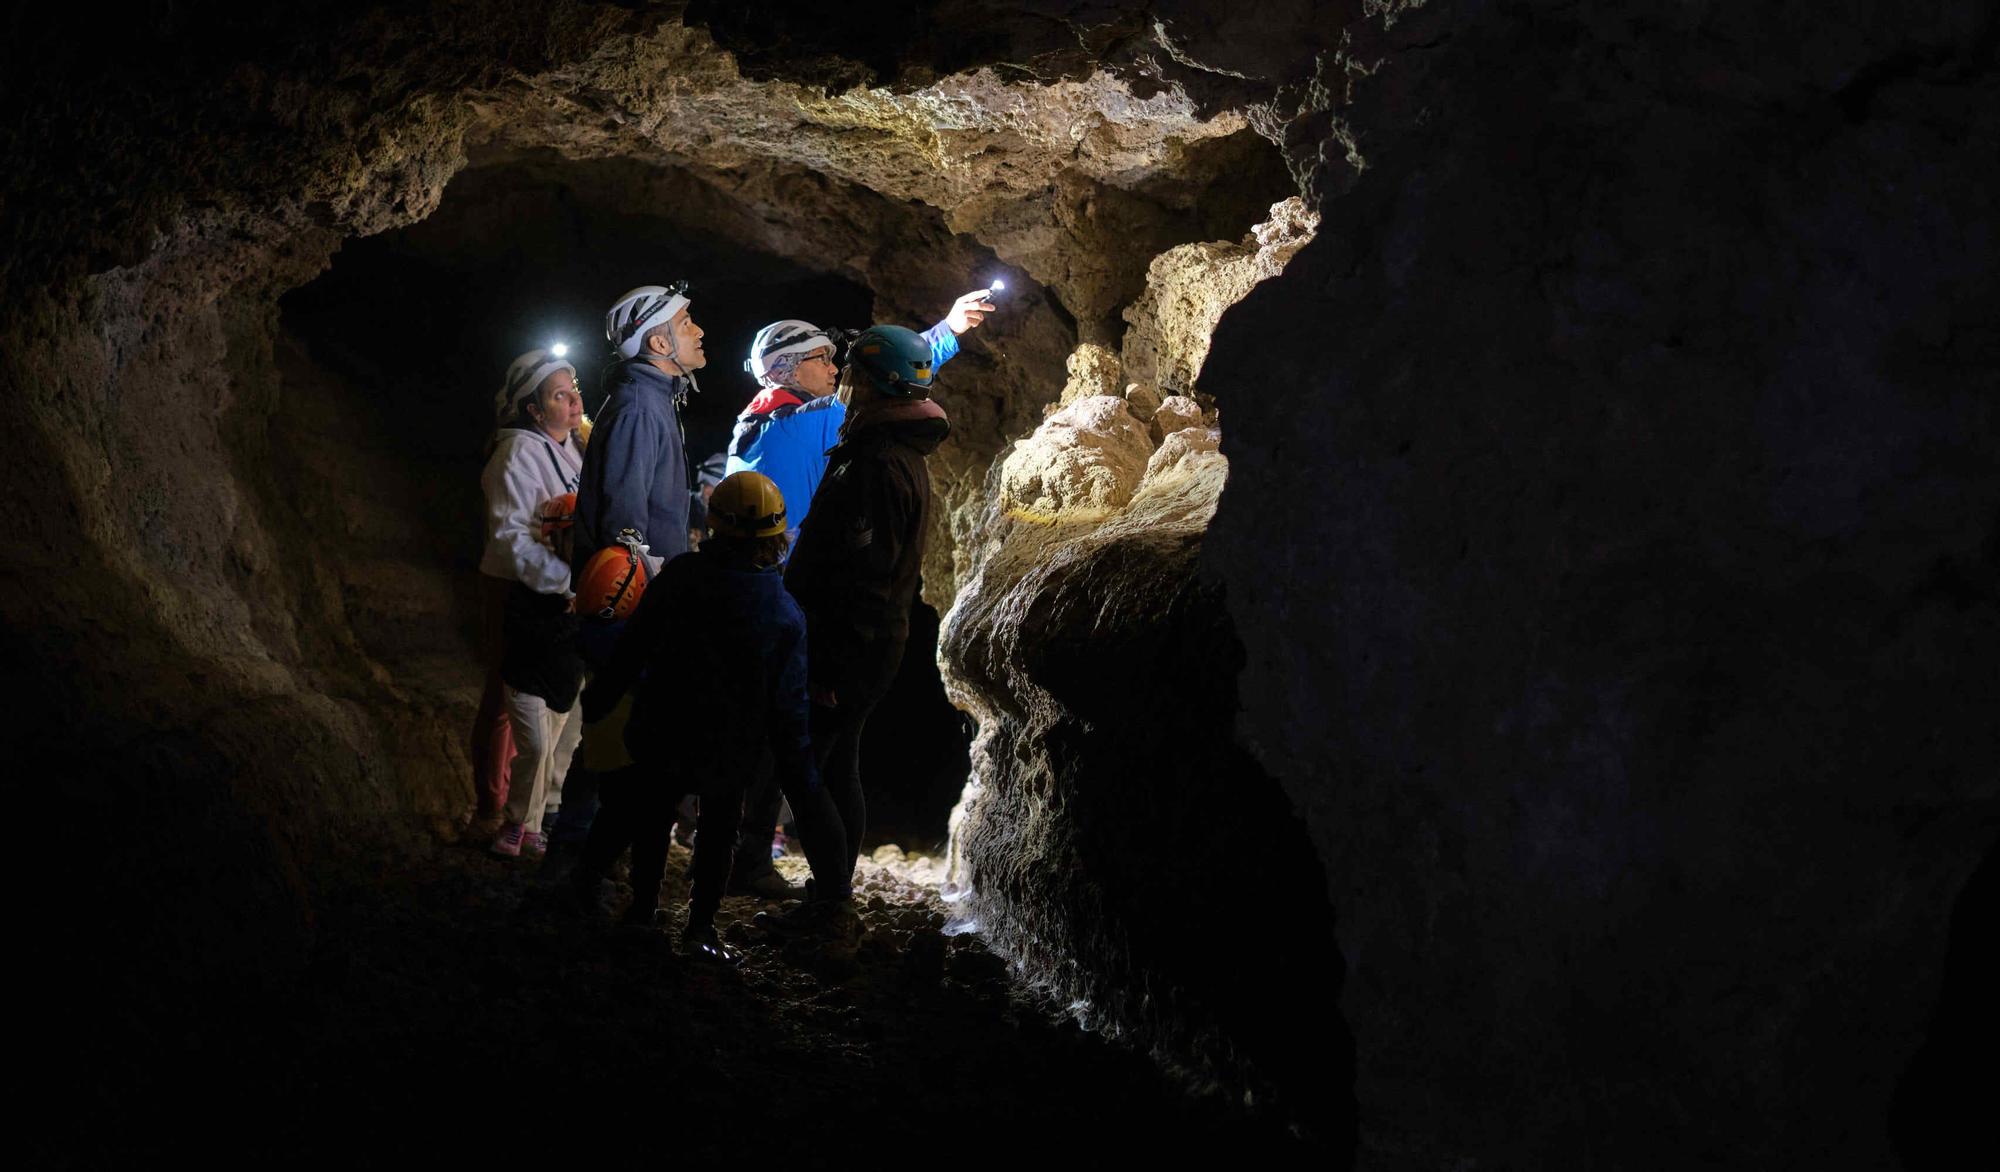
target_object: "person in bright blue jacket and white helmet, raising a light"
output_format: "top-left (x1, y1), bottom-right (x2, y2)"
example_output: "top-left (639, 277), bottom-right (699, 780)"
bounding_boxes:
top-left (726, 288), bottom-right (994, 538)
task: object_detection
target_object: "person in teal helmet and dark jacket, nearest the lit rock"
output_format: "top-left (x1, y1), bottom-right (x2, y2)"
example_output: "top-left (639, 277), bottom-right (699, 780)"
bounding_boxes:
top-left (786, 326), bottom-right (950, 904)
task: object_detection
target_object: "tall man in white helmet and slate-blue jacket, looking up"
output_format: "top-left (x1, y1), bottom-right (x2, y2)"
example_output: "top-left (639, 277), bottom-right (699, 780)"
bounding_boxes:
top-left (552, 280), bottom-right (708, 846)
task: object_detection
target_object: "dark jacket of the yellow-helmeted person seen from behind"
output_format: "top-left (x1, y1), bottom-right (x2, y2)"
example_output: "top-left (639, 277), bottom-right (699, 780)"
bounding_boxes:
top-left (584, 552), bottom-right (820, 792)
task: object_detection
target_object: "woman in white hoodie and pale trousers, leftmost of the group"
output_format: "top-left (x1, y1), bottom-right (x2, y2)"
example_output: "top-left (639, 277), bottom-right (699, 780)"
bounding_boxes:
top-left (474, 350), bottom-right (586, 856)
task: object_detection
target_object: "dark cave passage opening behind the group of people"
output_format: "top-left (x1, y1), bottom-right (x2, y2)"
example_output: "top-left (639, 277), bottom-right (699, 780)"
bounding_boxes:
top-left (274, 154), bottom-right (970, 852)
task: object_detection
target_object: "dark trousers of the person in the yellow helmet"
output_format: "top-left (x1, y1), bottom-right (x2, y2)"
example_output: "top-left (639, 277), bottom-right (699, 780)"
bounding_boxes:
top-left (576, 764), bottom-right (748, 928)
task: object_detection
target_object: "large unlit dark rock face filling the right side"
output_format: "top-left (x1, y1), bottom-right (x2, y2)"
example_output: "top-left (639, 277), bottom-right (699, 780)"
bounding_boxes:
top-left (1204, 4), bottom-right (2000, 1166)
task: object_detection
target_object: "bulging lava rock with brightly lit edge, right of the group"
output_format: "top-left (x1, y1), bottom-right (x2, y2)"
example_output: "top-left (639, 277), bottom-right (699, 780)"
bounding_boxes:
top-left (940, 410), bottom-right (1352, 1150)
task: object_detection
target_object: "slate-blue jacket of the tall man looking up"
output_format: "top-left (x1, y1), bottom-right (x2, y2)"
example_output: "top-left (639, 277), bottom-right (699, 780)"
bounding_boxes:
top-left (570, 358), bottom-right (688, 580)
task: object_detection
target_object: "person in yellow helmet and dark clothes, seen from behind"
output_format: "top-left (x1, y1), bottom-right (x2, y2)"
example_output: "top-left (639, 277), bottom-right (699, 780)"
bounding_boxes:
top-left (576, 472), bottom-right (846, 960)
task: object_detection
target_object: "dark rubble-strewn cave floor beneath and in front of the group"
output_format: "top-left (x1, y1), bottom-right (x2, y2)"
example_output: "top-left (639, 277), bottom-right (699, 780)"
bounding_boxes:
top-left (68, 832), bottom-right (1304, 1166)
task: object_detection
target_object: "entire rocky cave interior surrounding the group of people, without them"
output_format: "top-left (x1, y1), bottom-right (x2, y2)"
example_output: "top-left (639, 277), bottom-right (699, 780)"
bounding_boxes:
top-left (0, 0), bottom-right (2000, 1170)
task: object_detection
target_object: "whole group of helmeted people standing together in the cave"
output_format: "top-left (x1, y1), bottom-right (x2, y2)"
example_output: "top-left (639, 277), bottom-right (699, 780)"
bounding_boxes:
top-left (468, 282), bottom-right (994, 960)
